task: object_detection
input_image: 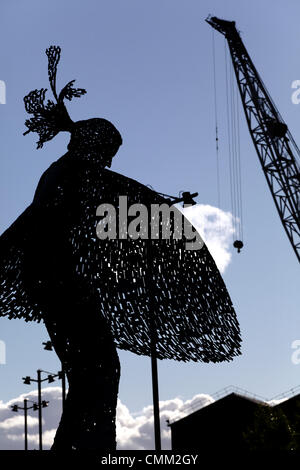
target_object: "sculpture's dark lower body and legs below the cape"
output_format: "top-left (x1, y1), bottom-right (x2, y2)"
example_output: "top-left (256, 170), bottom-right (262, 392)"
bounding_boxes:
top-left (45, 290), bottom-right (120, 451)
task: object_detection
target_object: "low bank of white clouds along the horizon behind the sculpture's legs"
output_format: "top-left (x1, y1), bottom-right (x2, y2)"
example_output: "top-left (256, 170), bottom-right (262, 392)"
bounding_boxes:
top-left (0, 387), bottom-right (214, 450)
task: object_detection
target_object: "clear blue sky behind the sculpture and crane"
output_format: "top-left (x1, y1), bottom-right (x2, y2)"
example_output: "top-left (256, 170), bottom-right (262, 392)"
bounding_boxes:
top-left (0, 0), bottom-right (300, 422)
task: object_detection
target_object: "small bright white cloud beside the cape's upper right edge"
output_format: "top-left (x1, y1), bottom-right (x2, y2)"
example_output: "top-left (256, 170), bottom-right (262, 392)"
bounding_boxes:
top-left (178, 204), bottom-right (234, 273)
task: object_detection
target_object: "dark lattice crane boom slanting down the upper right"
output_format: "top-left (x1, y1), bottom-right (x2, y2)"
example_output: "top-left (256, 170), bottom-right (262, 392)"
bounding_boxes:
top-left (206, 16), bottom-right (300, 262)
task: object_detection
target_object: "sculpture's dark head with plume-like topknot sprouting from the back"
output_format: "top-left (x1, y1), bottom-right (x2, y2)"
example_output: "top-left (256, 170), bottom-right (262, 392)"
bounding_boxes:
top-left (24, 46), bottom-right (122, 167)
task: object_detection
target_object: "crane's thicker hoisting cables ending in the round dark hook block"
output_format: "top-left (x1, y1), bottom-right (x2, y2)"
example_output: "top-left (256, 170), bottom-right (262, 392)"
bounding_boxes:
top-left (224, 38), bottom-right (243, 252)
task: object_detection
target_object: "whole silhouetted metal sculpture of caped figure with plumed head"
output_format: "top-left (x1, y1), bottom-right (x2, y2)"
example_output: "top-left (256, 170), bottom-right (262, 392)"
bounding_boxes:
top-left (0, 46), bottom-right (240, 450)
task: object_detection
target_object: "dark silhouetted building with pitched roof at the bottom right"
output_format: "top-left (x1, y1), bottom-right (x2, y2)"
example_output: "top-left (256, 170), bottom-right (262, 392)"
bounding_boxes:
top-left (169, 392), bottom-right (300, 452)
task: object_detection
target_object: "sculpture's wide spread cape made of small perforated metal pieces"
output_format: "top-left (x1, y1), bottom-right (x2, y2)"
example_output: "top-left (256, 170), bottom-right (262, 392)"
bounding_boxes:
top-left (0, 154), bottom-right (241, 362)
